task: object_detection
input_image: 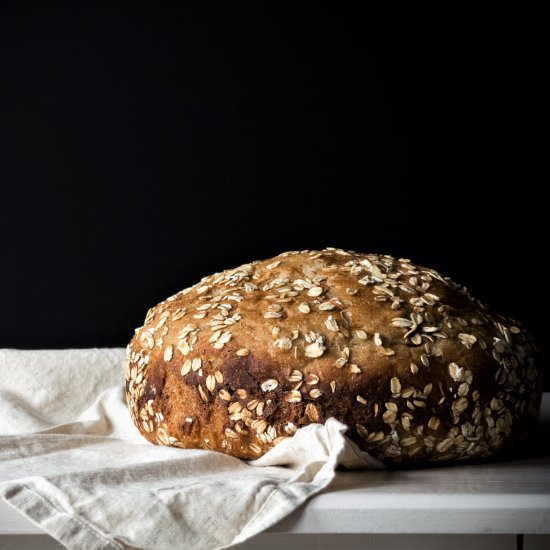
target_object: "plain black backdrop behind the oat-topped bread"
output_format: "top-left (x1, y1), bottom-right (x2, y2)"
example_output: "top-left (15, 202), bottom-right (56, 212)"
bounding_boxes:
top-left (0, 1), bottom-right (548, 388)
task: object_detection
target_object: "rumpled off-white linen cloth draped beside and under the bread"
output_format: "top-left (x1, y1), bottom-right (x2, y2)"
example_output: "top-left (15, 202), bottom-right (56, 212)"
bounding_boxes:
top-left (0, 349), bottom-right (381, 550)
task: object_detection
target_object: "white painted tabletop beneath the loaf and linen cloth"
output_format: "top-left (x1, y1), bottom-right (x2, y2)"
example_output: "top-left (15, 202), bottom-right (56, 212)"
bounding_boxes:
top-left (0, 393), bottom-right (550, 535)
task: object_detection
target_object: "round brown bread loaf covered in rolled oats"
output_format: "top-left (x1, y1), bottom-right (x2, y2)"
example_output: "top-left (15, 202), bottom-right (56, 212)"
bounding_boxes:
top-left (126, 248), bottom-right (541, 462)
